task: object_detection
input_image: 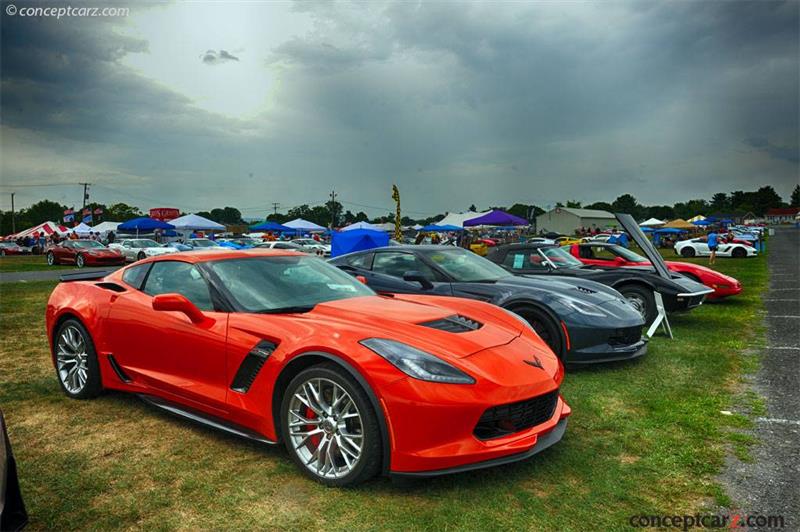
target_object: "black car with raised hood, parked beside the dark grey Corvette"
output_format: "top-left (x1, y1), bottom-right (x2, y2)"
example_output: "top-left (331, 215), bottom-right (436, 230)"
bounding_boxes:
top-left (486, 243), bottom-right (712, 323)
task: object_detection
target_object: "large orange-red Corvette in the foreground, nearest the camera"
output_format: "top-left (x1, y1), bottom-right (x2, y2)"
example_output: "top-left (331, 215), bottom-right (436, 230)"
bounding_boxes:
top-left (46, 250), bottom-right (571, 486)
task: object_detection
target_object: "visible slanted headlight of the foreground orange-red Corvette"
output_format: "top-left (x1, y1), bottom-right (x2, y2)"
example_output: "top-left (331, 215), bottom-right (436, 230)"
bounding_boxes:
top-left (359, 338), bottom-right (475, 384)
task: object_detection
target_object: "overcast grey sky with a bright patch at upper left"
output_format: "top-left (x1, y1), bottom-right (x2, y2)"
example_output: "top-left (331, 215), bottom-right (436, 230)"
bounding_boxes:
top-left (0, 0), bottom-right (800, 217)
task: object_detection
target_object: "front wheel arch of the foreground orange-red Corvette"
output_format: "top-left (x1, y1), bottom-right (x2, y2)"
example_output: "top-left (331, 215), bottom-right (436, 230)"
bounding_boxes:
top-left (271, 351), bottom-right (391, 474)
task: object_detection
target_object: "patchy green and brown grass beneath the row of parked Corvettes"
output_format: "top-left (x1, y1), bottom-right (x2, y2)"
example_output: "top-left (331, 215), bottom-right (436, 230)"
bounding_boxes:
top-left (0, 257), bottom-right (768, 530)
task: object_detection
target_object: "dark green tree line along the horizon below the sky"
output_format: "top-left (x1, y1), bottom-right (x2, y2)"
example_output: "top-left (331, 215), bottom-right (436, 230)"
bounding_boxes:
top-left (0, 185), bottom-right (800, 235)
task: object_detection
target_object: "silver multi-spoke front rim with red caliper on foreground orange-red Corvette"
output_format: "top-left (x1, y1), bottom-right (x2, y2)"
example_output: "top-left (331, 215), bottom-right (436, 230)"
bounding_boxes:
top-left (287, 378), bottom-right (364, 479)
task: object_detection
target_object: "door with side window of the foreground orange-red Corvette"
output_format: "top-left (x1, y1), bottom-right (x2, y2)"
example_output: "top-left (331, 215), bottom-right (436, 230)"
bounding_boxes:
top-left (108, 261), bottom-right (228, 411)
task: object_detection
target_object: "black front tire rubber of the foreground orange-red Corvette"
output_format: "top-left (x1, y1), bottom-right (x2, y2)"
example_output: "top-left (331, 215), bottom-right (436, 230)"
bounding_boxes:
top-left (279, 362), bottom-right (382, 487)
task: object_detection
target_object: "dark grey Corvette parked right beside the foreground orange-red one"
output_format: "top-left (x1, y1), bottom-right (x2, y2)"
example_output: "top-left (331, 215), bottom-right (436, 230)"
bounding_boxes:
top-left (331, 246), bottom-right (647, 363)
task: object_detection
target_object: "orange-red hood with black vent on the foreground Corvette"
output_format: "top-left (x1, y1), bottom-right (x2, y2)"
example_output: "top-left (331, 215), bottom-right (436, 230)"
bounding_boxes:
top-left (228, 296), bottom-right (523, 359)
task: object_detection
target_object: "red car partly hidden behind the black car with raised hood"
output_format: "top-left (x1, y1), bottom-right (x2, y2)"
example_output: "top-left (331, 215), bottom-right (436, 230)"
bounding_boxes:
top-left (564, 242), bottom-right (742, 299)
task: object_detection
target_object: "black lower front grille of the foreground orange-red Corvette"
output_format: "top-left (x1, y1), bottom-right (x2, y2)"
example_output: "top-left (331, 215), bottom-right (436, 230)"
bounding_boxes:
top-left (473, 388), bottom-right (558, 440)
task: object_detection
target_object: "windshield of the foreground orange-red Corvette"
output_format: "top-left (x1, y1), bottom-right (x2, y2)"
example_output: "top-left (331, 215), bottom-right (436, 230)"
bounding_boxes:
top-left (209, 255), bottom-right (375, 313)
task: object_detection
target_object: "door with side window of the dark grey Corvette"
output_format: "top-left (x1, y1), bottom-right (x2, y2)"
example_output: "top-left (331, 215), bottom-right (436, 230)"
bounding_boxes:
top-left (365, 250), bottom-right (452, 296)
